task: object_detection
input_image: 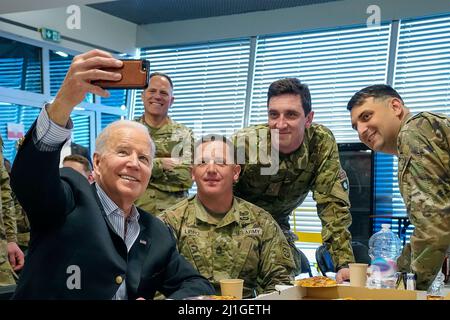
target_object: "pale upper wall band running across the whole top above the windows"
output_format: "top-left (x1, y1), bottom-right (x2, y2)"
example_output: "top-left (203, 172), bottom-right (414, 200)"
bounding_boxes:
top-left (0, 0), bottom-right (450, 54)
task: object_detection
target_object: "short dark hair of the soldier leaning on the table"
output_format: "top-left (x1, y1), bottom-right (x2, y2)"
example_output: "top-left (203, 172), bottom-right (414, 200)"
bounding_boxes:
top-left (267, 78), bottom-right (311, 116)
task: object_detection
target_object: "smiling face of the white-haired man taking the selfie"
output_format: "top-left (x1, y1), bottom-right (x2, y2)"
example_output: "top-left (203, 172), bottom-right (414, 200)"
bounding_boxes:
top-left (94, 126), bottom-right (152, 213)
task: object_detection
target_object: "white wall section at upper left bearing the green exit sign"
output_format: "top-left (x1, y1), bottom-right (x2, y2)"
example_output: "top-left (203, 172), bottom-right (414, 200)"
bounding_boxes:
top-left (0, 5), bottom-right (137, 55)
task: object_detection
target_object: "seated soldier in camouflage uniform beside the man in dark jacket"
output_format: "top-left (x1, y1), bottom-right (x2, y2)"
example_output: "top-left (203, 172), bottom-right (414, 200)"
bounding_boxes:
top-left (161, 136), bottom-right (294, 298)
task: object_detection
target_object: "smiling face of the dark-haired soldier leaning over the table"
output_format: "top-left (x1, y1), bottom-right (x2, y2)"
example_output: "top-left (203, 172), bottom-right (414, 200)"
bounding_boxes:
top-left (268, 94), bottom-right (314, 154)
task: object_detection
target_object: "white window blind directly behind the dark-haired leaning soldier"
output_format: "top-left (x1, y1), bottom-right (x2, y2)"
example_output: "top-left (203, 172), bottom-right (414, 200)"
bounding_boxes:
top-left (250, 25), bottom-right (390, 249)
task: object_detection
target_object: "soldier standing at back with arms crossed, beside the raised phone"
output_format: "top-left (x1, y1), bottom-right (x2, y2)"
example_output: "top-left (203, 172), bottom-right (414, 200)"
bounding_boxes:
top-left (136, 72), bottom-right (194, 215)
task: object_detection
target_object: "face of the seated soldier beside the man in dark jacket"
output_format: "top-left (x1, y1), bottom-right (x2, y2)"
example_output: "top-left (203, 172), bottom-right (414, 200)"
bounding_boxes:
top-left (192, 141), bottom-right (241, 197)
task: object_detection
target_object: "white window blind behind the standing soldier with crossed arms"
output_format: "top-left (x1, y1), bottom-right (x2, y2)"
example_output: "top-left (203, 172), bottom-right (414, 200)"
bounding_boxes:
top-left (133, 39), bottom-right (250, 137)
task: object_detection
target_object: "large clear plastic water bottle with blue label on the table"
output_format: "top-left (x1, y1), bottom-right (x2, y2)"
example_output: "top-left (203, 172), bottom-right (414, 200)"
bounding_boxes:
top-left (367, 224), bottom-right (402, 288)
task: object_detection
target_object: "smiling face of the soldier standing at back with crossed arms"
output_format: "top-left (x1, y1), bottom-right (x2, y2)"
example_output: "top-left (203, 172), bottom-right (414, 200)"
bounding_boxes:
top-left (142, 76), bottom-right (174, 118)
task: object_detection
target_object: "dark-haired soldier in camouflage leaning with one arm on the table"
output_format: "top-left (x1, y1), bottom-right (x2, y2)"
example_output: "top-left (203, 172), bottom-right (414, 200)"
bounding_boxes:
top-left (233, 78), bottom-right (354, 282)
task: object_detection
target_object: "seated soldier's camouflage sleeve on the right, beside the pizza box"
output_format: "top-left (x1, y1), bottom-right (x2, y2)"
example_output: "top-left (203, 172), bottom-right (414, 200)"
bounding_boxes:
top-left (258, 218), bottom-right (295, 293)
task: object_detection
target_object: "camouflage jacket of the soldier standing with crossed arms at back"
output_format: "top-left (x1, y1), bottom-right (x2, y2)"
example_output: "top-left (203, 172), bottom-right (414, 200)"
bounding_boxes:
top-left (135, 115), bottom-right (194, 214)
